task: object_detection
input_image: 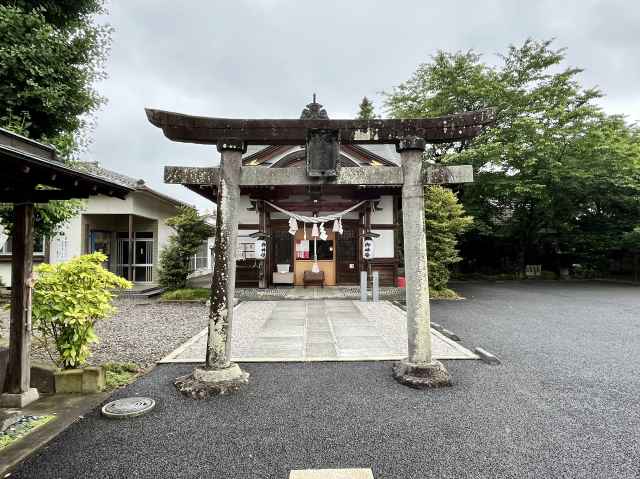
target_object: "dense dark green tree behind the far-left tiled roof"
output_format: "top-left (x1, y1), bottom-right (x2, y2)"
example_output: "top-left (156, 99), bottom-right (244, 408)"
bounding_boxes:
top-left (0, 0), bottom-right (111, 235)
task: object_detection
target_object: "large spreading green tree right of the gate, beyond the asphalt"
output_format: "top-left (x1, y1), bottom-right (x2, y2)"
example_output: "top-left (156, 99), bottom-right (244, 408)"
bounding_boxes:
top-left (386, 40), bottom-right (640, 270)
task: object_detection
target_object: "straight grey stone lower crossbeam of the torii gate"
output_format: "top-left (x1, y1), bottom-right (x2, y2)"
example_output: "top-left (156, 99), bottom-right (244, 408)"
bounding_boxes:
top-left (164, 165), bottom-right (473, 187)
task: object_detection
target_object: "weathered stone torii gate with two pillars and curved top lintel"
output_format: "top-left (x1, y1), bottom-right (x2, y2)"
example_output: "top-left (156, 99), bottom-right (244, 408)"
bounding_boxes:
top-left (146, 99), bottom-right (494, 398)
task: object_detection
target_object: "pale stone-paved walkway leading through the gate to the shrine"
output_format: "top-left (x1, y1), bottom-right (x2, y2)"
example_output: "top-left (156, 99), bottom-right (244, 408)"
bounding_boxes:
top-left (160, 299), bottom-right (477, 363)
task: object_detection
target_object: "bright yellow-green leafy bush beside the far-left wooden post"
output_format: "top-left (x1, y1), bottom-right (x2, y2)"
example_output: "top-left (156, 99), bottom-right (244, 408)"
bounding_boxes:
top-left (32, 253), bottom-right (131, 369)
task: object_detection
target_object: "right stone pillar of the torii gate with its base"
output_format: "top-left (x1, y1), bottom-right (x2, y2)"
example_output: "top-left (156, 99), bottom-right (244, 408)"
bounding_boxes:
top-left (393, 137), bottom-right (451, 389)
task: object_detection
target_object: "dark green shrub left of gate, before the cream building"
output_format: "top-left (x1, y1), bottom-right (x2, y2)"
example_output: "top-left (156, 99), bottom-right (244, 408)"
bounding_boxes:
top-left (160, 206), bottom-right (214, 290)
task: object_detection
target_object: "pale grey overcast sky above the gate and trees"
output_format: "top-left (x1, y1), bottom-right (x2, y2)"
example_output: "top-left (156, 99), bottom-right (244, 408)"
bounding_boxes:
top-left (89, 0), bottom-right (640, 209)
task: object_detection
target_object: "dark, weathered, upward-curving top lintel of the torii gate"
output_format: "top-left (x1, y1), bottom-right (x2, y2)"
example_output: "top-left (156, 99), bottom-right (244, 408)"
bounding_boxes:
top-left (145, 108), bottom-right (495, 145)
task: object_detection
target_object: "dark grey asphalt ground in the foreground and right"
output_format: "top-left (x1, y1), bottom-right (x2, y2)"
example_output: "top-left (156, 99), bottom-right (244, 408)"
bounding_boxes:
top-left (12, 282), bottom-right (640, 479)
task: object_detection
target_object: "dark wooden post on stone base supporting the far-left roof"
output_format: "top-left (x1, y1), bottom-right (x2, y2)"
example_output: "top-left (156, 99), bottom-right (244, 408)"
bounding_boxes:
top-left (0, 203), bottom-right (38, 407)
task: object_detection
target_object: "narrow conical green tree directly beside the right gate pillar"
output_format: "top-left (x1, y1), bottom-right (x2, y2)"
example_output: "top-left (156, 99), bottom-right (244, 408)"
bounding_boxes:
top-left (424, 186), bottom-right (473, 291)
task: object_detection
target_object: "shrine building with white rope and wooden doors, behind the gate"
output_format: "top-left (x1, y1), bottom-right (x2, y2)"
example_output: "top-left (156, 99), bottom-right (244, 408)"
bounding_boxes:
top-left (230, 130), bottom-right (402, 287)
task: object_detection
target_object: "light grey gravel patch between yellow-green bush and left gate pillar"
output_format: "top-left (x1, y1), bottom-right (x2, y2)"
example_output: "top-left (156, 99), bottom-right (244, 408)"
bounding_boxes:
top-left (0, 298), bottom-right (207, 368)
